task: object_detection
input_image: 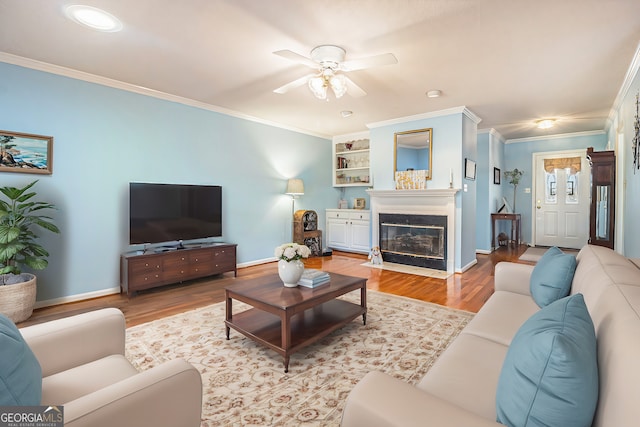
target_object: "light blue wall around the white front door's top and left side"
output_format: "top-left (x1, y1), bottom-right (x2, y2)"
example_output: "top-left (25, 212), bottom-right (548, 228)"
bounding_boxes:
top-left (502, 132), bottom-right (607, 247)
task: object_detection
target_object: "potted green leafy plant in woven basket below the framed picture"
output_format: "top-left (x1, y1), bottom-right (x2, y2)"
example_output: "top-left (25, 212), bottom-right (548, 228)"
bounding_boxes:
top-left (0, 180), bottom-right (60, 323)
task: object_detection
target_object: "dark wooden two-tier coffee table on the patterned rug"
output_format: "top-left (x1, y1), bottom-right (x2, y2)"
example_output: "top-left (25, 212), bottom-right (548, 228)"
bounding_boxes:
top-left (224, 273), bottom-right (367, 372)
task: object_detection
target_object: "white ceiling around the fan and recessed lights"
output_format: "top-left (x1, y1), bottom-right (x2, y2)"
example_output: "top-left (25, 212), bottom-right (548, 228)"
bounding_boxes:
top-left (0, 0), bottom-right (640, 139)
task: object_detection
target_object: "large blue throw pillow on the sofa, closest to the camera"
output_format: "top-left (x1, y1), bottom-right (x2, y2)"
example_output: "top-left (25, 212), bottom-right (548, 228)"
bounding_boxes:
top-left (496, 294), bottom-right (598, 427)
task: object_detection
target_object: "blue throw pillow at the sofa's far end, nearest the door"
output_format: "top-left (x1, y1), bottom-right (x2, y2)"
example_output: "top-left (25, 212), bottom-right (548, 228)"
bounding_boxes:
top-left (529, 246), bottom-right (576, 308)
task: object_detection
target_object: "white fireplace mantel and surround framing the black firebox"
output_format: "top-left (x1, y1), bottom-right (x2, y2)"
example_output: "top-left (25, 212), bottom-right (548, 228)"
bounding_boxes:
top-left (367, 188), bottom-right (460, 274)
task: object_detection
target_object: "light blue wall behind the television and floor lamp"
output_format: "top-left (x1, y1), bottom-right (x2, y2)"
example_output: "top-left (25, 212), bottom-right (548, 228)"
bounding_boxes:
top-left (0, 63), bottom-right (339, 301)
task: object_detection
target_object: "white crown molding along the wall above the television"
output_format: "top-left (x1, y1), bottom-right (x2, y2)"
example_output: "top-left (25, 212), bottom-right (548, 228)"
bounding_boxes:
top-left (0, 52), bottom-right (331, 140)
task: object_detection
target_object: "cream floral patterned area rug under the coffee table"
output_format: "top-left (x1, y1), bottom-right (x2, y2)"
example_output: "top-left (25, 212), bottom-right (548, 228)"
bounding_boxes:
top-left (127, 290), bottom-right (473, 427)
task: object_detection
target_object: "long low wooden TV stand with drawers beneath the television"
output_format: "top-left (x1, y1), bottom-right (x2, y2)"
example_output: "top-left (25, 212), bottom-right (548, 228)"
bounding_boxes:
top-left (120, 243), bottom-right (238, 296)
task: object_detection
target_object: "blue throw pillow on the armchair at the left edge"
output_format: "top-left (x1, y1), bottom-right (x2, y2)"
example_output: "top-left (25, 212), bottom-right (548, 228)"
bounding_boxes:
top-left (0, 314), bottom-right (42, 406)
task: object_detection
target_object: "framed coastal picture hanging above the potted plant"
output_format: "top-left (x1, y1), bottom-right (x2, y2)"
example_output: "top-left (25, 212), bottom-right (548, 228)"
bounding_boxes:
top-left (0, 130), bottom-right (53, 175)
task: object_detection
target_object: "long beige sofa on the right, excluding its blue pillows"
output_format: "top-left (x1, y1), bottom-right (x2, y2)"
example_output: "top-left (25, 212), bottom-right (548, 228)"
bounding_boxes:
top-left (342, 246), bottom-right (640, 427)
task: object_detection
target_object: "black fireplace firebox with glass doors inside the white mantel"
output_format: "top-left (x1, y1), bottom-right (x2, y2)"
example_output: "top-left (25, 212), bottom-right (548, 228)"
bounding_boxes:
top-left (378, 213), bottom-right (447, 271)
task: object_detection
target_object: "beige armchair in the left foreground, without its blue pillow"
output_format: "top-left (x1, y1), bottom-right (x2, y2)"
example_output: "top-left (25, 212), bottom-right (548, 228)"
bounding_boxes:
top-left (20, 308), bottom-right (202, 427)
